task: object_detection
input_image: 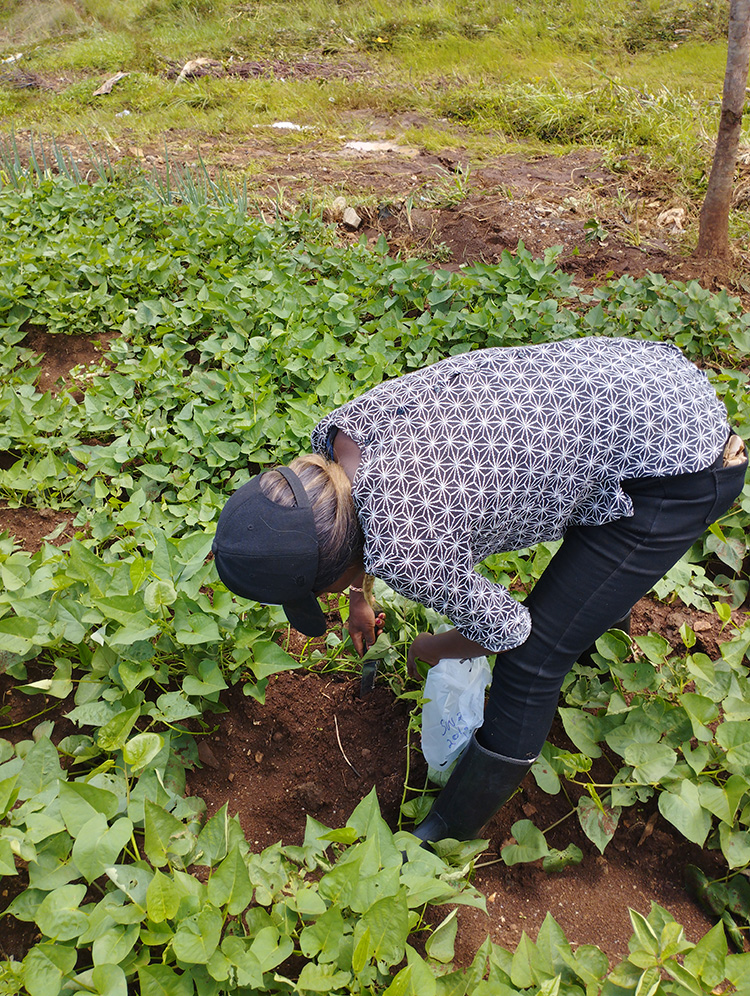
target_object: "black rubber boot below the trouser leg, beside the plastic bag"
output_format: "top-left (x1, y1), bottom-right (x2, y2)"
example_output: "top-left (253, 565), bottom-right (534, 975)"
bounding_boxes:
top-left (412, 735), bottom-right (534, 842)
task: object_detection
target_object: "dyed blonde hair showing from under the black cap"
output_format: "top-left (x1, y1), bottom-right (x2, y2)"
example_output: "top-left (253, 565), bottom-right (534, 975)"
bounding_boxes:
top-left (260, 453), bottom-right (364, 591)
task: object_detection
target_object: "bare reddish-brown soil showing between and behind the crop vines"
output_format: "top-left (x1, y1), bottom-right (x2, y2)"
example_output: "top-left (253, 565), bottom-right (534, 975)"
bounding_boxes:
top-left (0, 124), bottom-right (745, 964)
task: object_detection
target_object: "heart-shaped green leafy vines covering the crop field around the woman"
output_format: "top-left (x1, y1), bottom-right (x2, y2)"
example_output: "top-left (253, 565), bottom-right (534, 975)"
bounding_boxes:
top-left (0, 170), bottom-right (750, 996)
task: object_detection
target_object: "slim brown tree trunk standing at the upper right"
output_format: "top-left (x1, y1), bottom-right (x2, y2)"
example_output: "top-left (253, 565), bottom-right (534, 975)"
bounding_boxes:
top-left (695, 0), bottom-right (750, 256)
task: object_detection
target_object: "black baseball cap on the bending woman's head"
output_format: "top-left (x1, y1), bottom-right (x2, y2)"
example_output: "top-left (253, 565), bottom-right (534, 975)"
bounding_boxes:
top-left (211, 467), bottom-right (326, 636)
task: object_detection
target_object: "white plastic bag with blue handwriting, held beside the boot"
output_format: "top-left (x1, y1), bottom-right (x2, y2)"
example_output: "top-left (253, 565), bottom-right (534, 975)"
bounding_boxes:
top-left (422, 657), bottom-right (492, 783)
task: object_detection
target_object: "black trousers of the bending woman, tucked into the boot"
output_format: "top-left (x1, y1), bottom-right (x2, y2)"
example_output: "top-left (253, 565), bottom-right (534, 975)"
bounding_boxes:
top-left (477, 460), bottom-right (747, 759)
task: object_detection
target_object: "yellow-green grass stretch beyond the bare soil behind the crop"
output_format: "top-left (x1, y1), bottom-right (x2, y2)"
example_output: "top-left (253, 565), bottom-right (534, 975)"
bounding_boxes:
top-left (0, 0), bottom-right (740, 210)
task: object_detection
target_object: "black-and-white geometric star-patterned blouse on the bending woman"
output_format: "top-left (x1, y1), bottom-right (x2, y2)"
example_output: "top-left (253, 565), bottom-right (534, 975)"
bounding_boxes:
top-left (312, 337), bottom-right (729, 652)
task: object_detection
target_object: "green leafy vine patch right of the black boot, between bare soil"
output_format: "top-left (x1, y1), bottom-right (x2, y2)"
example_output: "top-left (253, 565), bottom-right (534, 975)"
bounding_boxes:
top-left (496, 625), bottom-right (750, 868)
